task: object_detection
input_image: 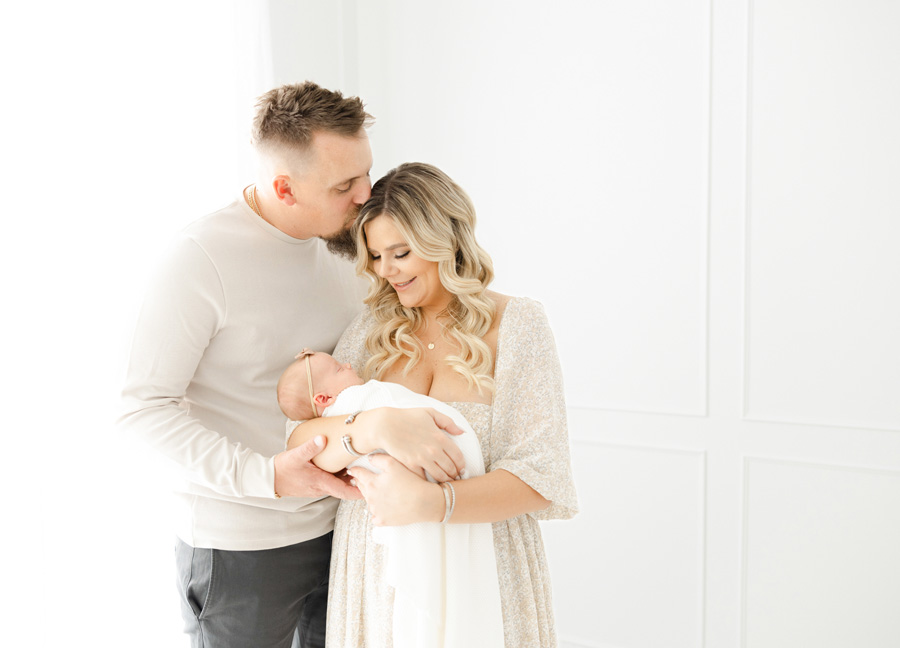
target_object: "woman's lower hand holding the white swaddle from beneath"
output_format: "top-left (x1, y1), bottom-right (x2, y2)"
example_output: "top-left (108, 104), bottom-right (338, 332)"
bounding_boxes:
top-left (347, 456), bottom-right (452, 526)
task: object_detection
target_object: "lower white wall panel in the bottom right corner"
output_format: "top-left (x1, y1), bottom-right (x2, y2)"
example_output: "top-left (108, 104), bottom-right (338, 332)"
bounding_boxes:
top-left (740, 456), bottom-right (900, 648)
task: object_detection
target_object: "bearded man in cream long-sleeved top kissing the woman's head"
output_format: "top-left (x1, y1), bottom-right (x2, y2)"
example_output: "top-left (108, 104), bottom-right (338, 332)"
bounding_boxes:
top-left (120, 82), bottom-right (461, 648)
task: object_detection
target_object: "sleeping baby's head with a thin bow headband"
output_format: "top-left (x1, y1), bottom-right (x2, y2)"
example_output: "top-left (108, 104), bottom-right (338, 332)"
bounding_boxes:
top-left (277, 349), bottom-right (363, 421)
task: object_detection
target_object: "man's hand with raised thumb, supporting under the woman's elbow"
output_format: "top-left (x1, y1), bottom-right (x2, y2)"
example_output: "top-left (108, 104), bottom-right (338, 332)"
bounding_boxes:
top-left (275, 435), bottom-right (362, 499)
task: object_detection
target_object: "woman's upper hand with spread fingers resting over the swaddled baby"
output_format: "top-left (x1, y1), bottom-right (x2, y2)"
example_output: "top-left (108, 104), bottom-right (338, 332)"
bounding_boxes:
top-left (377, 408), bottom-right (465, 481)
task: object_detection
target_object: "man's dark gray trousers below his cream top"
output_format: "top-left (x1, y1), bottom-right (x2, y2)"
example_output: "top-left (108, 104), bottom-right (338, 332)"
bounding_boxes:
top-left (175, 533), bottom-right (332, 648)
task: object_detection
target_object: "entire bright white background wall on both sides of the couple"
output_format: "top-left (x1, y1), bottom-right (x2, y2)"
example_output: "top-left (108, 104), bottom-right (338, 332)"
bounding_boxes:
top-left (14, 0), bottom-right (900, 648)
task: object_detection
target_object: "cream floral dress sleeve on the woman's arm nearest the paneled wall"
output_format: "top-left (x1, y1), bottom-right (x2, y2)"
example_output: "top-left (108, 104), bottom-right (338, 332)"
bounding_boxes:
top-left (490, 298), bottom-right (578, 520)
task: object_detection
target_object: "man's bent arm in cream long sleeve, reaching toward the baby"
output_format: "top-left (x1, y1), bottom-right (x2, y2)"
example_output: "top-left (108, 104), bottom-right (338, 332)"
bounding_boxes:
top-left (119, 238), bottom-right (344, 499)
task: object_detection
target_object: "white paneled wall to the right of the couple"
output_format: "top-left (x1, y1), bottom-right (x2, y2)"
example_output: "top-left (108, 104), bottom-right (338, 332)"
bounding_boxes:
top-left (332, 0), bottom-right (900, 648)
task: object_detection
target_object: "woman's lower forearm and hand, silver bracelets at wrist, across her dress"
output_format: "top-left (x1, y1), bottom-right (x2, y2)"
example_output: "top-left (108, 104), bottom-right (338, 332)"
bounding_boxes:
top-left (348, 455), bottom-right (551, 526)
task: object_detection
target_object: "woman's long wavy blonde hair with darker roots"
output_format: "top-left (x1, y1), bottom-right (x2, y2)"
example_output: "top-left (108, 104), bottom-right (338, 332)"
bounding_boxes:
top-left (353, 162), bottom-right (495, 394)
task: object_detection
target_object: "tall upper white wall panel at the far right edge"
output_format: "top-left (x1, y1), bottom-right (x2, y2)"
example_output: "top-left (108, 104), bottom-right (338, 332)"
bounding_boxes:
top-left (745, 0), bottom-right (900, 431)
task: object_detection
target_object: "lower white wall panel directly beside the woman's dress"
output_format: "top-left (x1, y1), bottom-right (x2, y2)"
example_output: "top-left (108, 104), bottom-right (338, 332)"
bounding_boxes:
top-left (543, 442), bottom-right (707, 648)
